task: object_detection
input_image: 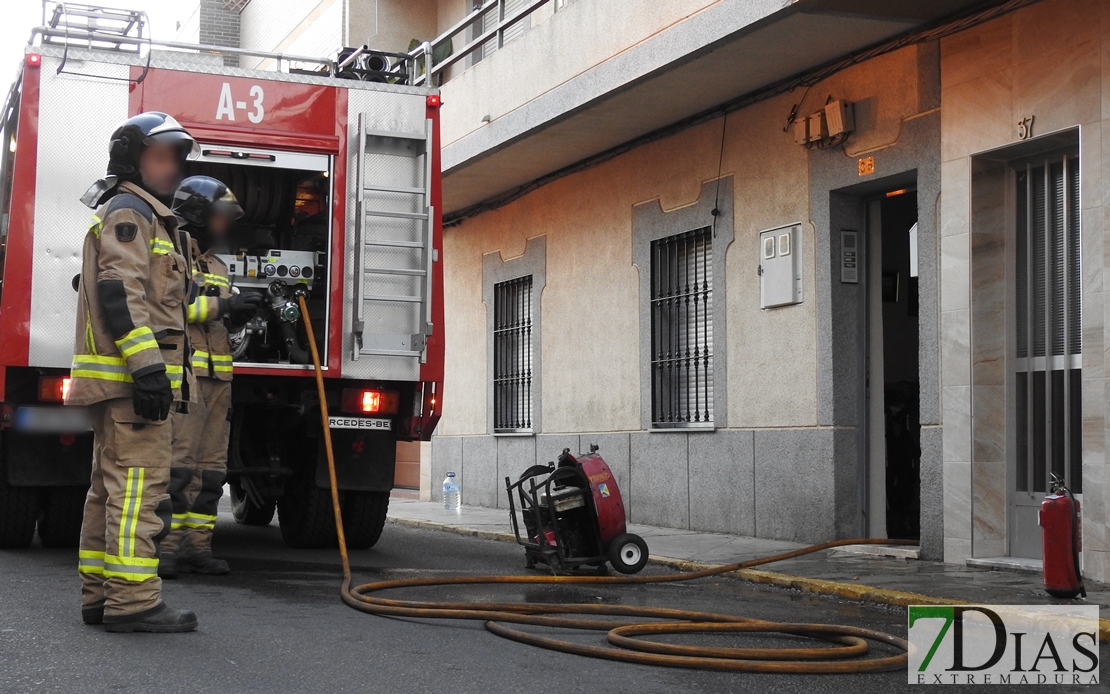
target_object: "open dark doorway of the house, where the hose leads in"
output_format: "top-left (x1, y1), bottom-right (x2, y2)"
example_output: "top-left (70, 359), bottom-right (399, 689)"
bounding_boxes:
top-left (867, 189), bottom-right (921, 540)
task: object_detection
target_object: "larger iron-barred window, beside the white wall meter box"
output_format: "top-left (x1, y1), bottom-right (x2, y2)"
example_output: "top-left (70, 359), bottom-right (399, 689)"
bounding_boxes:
top-left (652, 227), bottom-right (714, 429)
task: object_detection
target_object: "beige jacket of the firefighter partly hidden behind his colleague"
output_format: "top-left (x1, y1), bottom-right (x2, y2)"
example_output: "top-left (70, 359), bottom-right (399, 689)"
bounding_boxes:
top-left (186, 236), bottom-right (231, 381)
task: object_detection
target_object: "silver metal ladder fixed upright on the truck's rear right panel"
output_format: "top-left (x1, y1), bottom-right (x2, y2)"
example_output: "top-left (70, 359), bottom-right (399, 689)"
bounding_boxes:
top-left (351, 113), bottom-right (435, 363)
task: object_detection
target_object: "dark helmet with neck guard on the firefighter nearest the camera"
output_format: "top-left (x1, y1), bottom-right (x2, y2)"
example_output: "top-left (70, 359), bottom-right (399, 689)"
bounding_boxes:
top-left (81, 111), bottom-right (200, 209)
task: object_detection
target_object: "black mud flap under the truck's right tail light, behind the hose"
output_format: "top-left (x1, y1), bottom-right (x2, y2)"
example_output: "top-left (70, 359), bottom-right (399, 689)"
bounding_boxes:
top-left (316, 430), bottom-right (397, 492)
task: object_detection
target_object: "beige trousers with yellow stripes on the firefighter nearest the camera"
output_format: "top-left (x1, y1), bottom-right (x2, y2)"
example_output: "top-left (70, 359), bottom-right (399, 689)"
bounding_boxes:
top-left (78, 398), bottom-right (172, 620)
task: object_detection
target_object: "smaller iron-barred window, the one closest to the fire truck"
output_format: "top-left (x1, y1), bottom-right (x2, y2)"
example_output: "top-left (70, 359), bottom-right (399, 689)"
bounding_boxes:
top-left (493, 274), bottom-right (534, 433)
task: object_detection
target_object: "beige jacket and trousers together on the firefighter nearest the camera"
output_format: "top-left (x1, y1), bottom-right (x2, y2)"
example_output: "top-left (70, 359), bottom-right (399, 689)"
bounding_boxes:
top-left (65, 183), bottom-right (192, 622)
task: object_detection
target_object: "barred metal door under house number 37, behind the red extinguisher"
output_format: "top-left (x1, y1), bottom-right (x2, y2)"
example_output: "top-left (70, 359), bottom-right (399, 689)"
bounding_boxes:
top-left (1010, 152), bottom-right (1082, 557)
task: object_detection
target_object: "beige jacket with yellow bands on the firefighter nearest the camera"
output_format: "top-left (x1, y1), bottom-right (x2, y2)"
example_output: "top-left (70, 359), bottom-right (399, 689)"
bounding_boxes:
top-left (65, 182), bottom-right (192, 405)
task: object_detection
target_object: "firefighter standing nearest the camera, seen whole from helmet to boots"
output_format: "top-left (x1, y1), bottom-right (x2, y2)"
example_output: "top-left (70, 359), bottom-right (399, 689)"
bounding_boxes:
top-left (65, 111), bottom-right (199, 632)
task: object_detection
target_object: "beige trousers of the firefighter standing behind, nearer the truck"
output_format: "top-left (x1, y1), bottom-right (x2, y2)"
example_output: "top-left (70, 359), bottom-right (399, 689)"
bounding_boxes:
top-left (162, 376), bottom-right (231, 556)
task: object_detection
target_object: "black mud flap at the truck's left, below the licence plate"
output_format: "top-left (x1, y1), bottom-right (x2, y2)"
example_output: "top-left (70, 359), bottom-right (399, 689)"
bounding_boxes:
top-left (0, 431), bottom-right (92, 486)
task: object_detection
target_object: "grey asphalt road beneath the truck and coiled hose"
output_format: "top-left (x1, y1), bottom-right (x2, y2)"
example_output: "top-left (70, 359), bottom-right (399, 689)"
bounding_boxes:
top-left (0, 504), bottom-right (1110, 694)
